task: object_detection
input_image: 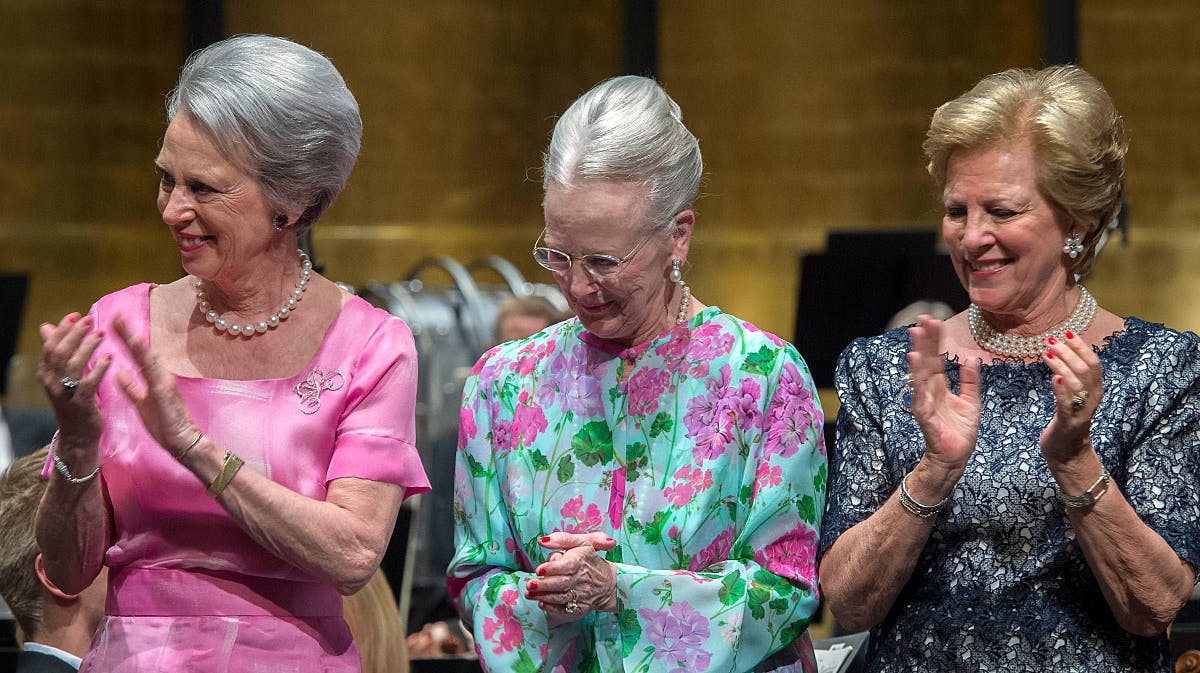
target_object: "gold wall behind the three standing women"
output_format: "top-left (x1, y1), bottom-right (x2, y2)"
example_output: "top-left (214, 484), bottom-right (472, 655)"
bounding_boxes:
top-left (7, 0), bottom-right (1200, 399)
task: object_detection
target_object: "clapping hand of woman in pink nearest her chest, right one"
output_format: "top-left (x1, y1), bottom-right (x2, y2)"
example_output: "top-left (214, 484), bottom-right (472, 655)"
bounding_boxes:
top-left (113, 319), bottom-right (199, 457)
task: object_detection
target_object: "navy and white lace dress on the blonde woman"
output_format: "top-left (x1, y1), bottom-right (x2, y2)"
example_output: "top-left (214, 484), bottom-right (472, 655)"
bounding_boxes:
top-left (821, 318), bottom-right (1200, 673)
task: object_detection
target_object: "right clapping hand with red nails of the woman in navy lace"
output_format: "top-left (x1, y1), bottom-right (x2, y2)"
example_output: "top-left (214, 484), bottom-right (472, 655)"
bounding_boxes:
top-left (1040, 331), bottom-right (1104, 463)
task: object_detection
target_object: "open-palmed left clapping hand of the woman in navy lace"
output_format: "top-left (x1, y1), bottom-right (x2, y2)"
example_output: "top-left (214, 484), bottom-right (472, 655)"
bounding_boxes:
top-left (908, 316), bottom-right (979, 470)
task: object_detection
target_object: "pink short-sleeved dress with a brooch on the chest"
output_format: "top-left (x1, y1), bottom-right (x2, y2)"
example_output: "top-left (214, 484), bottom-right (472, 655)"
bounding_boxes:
top-left (57, 284), bottom-right (428, 673)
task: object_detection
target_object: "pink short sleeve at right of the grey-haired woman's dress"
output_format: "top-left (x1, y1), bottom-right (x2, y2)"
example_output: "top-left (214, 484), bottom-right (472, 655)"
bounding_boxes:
top-left (325, 317), bottom-right (430, 497)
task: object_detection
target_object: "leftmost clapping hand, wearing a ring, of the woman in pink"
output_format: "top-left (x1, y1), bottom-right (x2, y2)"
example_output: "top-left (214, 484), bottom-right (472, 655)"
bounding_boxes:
top-left (37, 313), bottom-right (113, 464)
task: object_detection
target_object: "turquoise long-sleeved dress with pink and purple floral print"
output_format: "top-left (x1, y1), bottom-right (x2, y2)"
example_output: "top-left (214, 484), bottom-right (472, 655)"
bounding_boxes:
top-left (449, 307), bottom-right (827, 673)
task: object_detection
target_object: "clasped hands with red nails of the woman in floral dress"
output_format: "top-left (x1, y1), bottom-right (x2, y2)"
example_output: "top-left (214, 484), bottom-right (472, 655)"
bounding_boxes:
top-left (526, 533), bottom-right (617, 625)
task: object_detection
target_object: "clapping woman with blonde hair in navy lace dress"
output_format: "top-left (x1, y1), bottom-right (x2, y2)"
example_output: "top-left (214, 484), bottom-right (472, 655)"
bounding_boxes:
top-left (821, 66), bottom-right (1200, 673)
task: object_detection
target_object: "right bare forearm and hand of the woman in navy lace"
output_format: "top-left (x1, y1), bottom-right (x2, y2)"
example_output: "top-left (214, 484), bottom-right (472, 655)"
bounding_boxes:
top-left (1040, 335), bottom-right (1195, 636)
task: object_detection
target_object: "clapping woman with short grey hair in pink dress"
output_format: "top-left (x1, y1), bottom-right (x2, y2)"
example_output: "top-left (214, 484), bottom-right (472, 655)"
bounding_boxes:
top-left (37, 35), bottom-right (427, 672)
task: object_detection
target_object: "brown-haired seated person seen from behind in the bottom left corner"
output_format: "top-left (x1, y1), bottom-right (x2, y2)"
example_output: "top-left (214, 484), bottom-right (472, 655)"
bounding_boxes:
top-left (0, 449), bottom-right (107, 673)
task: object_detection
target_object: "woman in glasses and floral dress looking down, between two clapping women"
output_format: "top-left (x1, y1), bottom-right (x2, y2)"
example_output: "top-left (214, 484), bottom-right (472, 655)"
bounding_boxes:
top-left (449, 77), bottom-right (826, 673)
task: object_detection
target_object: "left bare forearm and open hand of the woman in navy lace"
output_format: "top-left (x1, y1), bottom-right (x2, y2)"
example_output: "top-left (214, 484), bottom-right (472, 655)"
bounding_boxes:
top-left (820, 316), bottom-right (979, 631)
